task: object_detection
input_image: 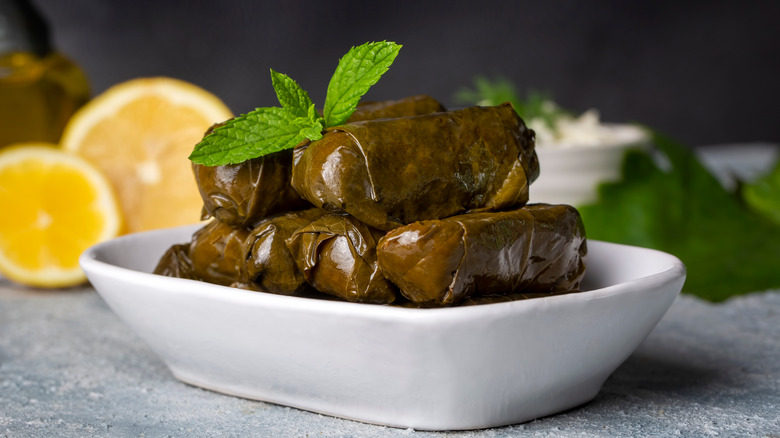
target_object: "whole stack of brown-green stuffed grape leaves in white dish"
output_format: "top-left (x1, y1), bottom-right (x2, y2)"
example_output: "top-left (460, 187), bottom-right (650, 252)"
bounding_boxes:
top-left (155, 96), bottom-right (587, 307)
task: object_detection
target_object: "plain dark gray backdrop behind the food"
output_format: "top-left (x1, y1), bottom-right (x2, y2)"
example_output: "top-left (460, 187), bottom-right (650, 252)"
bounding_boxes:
top-left (34, 0), bottom-right (780, 146)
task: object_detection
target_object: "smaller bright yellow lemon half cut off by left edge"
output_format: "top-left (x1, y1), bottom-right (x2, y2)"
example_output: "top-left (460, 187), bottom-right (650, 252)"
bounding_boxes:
top-left (0, 143), bottom-right (121, 287)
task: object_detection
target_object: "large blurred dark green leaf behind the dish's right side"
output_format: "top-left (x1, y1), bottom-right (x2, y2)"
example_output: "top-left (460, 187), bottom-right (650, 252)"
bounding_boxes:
top-left (579, 134), bottom-right (780, 301)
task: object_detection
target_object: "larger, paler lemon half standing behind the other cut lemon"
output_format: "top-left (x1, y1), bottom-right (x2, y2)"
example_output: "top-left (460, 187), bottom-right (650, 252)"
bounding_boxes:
top-left (61, 77), bottom-right (233, 232)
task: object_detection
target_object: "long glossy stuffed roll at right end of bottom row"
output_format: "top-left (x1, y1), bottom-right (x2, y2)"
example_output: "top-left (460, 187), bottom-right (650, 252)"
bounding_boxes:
top-left (377, 204), bottom-right (587, 306)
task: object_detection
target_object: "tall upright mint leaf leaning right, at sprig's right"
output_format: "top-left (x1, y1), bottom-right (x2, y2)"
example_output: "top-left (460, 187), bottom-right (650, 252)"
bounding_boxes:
top-left (323, 41), bottom-right (401, 126)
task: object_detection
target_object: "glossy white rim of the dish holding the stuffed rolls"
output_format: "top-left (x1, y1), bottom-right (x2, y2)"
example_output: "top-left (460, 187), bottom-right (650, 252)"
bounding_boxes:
top-left (79, 223), bottom-right (686, 320)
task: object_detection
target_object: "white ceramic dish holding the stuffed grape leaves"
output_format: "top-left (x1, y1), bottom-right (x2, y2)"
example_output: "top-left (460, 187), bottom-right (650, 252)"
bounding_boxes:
top-left (81, 226), bottom-right (685, 430)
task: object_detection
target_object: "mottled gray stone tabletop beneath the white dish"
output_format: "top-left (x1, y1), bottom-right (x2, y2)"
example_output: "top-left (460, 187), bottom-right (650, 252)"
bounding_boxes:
top-left (0, 279), bottom-right (780, 438)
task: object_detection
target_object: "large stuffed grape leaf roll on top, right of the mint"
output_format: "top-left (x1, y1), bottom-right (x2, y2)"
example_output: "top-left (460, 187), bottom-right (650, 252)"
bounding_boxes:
top-left (292, 103), bottom-right (539, 231)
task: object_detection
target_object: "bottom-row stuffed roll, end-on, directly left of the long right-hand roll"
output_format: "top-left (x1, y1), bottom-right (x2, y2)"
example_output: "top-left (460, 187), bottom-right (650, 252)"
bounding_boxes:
top-left (287, 214), bottom-right (397, 304)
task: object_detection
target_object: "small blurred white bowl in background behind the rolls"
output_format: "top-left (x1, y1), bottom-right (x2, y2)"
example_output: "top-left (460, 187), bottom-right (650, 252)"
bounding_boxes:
top-left (530, 125), bottom-right (650, 207)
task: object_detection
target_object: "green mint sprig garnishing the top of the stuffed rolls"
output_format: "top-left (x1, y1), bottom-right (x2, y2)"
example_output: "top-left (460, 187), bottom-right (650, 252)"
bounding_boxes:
top-left (189, 41), bottom-right (401, 166)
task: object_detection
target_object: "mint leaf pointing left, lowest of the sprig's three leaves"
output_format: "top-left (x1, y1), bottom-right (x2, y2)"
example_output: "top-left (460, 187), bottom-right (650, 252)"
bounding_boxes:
top-left (189, 107), bottom-right (310, 166)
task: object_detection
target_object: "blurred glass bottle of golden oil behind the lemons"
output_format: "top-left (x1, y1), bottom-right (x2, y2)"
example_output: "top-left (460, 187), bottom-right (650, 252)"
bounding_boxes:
top-left (0, 0), bottom-right (90, 149)
